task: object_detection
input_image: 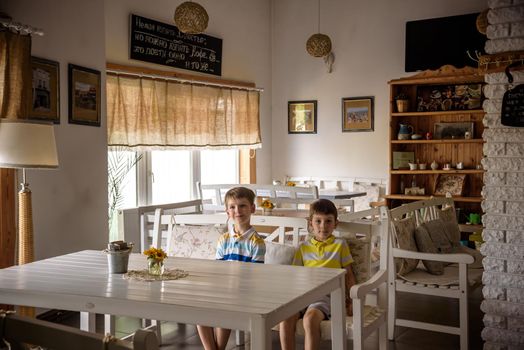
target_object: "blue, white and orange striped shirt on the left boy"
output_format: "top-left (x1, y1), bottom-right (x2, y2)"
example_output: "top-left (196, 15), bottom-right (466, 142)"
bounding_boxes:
top-left (216, 227), bottom-right (266, 263)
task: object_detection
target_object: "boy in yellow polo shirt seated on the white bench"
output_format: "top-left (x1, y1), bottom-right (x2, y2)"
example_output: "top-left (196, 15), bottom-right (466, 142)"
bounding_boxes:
top-left (280, 199), bottom-right (355, 350)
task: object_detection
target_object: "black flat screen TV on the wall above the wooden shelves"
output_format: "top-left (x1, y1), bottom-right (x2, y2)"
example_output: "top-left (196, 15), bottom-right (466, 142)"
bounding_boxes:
top-left (405, 13), bottom-right (486, 72)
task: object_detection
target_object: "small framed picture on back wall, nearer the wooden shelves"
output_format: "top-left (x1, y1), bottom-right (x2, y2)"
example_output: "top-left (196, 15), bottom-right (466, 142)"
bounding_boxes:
top-left (342, 96), bottom-right (374, 132)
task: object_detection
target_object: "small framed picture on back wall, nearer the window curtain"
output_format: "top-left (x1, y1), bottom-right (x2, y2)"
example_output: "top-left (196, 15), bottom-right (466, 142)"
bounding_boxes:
top-left (287, 101), bottom-right (317, 134)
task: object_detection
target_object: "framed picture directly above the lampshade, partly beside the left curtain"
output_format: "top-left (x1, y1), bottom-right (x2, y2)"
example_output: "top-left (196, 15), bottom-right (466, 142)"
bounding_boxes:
top-left (27, 57), bottom-right (60, 124)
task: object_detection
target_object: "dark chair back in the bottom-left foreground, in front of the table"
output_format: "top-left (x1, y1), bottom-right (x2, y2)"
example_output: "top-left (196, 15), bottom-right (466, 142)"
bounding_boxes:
top-left (0, 310), bottom-right (158, 350)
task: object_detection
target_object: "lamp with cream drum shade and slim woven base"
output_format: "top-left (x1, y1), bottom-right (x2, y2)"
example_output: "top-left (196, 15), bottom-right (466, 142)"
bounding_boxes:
top-left (0, 119), bottom-right (58, 265)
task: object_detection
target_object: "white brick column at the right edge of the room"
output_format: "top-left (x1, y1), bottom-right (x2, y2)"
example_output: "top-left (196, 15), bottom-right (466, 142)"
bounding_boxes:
top-left (481, 0), bottom-right (524, 350)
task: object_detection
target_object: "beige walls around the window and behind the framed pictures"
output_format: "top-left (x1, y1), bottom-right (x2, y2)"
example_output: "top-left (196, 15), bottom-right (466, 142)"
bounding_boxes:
top-left (0, 0), bottom-right (486, 259)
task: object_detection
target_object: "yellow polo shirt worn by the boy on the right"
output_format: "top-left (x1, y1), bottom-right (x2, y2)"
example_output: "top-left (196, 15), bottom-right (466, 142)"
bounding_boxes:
top-left (293, 235), bottom-right (353, 269)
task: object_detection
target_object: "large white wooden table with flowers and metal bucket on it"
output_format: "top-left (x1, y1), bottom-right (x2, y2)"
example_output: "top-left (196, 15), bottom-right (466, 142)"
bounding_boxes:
top-left (0, 250), bottom-right (346, 350)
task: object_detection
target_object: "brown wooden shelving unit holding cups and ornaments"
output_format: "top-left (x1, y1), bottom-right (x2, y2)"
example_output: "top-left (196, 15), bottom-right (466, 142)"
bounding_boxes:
top-left (386, 66), bottom-right (484, 227)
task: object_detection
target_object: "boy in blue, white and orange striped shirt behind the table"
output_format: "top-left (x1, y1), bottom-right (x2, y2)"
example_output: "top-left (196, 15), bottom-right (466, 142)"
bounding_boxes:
top-left (197, 187), bottom-right (266, 350)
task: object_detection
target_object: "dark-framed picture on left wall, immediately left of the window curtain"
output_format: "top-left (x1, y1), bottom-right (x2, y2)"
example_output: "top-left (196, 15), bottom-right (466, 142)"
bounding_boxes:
top-left (69, 64), bottom-right (102, 126)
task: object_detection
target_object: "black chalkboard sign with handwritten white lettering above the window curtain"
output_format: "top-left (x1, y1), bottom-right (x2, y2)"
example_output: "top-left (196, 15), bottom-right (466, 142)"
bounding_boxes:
top-left (129, 14), bottom-right (222, 76)
